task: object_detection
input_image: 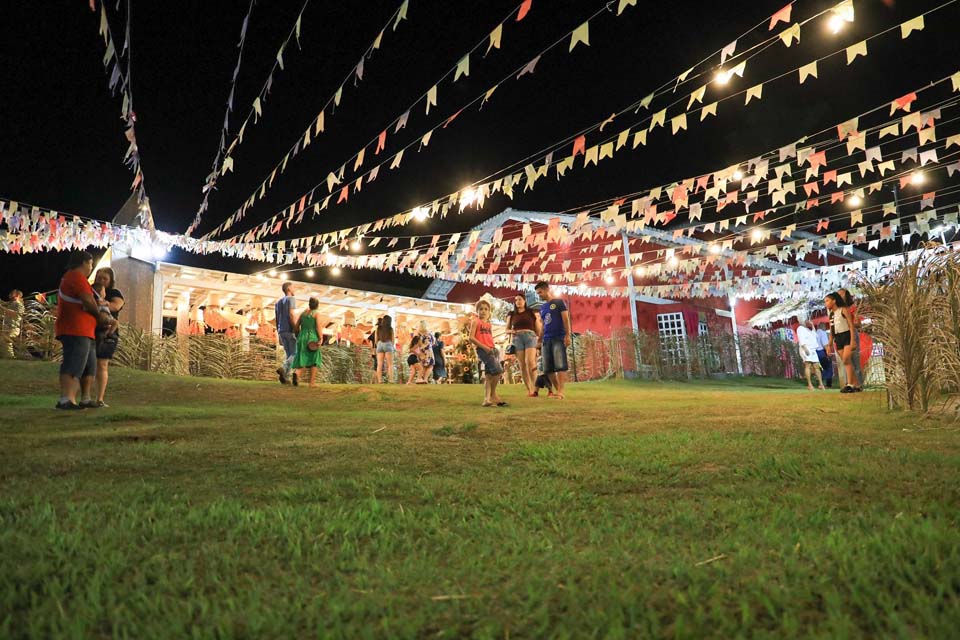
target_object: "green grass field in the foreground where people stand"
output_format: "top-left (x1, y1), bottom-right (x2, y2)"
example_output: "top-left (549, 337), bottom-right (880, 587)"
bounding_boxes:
top-left (0, 361), bottom-right (960, 638)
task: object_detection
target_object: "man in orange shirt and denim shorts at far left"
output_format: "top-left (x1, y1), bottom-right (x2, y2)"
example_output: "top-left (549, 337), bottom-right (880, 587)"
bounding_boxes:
top-left (54, 251), bottom-right (116, 410)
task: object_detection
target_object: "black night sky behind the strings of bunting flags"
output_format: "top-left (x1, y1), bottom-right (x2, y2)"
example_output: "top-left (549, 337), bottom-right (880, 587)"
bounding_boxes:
top-left (0, 0), bottom-right (960, 294)
